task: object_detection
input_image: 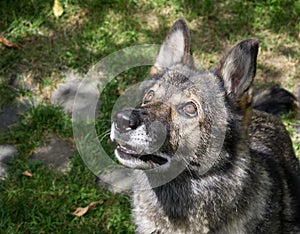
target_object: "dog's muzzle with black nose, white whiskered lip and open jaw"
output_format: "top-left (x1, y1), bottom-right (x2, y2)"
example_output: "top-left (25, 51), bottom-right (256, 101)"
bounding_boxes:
top-left (111, 108), bottom-right (168, 169)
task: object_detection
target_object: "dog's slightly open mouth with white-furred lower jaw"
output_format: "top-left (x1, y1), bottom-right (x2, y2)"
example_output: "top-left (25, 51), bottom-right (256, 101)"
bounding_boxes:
top-left (116, 144), bottom-right (168, 169)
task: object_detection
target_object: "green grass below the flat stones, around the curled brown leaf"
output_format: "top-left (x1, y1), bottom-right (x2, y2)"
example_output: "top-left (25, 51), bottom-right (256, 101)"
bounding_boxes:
top-left (0, 154), bottom-right (133, 233)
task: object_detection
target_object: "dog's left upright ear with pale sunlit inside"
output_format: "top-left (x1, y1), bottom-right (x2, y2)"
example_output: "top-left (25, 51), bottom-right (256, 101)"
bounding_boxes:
top-left (151, 19), bottom-right (193, 75)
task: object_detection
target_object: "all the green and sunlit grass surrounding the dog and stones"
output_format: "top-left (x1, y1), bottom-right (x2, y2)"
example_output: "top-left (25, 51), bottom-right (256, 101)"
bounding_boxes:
top-left (0, 0), bottom-right (300, 233)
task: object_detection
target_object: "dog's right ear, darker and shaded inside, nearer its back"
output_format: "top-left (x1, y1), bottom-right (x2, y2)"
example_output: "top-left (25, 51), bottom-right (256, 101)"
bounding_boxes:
top-left (213, 38), bottom-right (259, 107)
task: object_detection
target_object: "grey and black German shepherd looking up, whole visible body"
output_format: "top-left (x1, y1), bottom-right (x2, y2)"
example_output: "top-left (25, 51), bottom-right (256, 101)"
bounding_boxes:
top-left (111, 19), bottom-right (300, 234)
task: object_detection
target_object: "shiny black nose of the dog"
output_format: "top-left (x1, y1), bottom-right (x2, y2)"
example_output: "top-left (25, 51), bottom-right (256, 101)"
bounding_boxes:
top-left (114, 109), bottom-right (142, 132)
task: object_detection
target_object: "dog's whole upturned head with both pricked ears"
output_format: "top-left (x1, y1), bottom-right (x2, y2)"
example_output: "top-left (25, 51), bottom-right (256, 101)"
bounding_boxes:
top-left (111, 19), bottom-right (258, 172)
